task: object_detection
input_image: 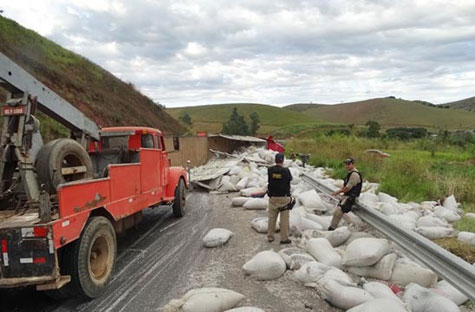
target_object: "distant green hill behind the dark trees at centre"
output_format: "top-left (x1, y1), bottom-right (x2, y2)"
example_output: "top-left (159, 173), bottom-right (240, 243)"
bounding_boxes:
top-left (167, 103), bottom-right (315, 134)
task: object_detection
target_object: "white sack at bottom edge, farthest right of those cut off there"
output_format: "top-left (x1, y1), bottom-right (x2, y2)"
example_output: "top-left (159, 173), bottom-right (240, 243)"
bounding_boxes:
top-left (403, 284), bottom-right (460, 312)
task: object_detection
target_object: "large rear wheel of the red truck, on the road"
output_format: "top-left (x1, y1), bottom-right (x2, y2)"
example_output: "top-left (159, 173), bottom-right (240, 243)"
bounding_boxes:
top-left (54, 216), bottom-right (117, 299)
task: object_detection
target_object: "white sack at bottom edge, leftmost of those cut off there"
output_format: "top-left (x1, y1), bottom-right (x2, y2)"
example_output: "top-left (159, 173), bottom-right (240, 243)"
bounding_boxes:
top-left (161, 288), bottom-right (245, 312)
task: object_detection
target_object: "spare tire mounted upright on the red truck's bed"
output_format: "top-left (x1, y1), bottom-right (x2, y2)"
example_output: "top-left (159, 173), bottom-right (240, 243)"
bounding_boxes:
top-left (35, 139), bottom-right (93, 194)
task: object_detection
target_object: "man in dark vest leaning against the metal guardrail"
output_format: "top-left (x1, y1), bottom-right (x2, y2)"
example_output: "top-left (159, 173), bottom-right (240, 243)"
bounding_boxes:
top-left (328, 157), bottom-right (363, 231)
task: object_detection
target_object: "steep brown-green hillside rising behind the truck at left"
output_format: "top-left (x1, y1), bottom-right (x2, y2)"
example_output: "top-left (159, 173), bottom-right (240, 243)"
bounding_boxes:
top-left (0, 17), bottom-right (186, 134)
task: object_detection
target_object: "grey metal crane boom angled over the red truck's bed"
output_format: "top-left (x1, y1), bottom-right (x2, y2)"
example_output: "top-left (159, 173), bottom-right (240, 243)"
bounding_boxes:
top-left (0, 53), bottom-right (99, 140)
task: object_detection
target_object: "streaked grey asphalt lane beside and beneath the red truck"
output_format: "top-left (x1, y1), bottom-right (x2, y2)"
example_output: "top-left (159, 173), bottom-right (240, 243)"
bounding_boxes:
top-left (0, 192), bottom-right (212, 312)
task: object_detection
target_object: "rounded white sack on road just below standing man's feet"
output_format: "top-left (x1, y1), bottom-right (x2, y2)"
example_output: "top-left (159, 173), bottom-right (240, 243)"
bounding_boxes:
top-left (242, 250), bottom-right (286, 281)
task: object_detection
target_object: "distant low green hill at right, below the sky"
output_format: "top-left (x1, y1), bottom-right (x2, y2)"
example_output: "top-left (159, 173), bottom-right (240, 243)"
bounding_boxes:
top-left (302, 98), bottom-right (475, 129)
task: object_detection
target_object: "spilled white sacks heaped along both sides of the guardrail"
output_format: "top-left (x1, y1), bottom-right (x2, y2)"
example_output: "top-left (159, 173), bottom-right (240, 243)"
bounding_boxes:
top-left (192, 148), bottom-right (475, 312)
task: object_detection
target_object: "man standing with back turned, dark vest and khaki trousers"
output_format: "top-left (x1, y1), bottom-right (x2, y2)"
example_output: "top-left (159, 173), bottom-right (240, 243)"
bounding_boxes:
top-left (267, 153), bottom-right (292, 244)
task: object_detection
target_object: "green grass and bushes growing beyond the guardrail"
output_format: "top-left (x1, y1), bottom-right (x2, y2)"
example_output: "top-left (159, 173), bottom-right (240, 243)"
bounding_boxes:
top-left (285, 125), bottom-right (475, 262)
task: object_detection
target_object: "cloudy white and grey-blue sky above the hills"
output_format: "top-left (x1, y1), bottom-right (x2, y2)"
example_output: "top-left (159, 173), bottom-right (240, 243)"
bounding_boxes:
top-left (0, 0), bottom-right (475, 107)
